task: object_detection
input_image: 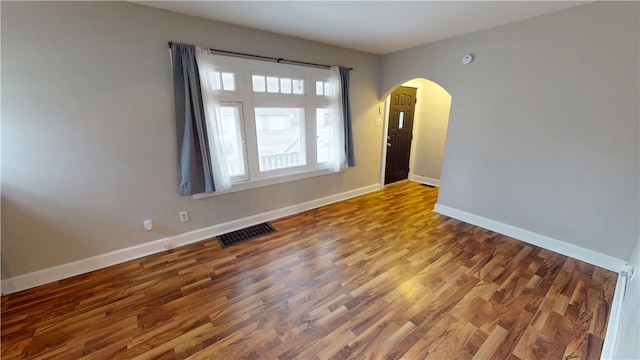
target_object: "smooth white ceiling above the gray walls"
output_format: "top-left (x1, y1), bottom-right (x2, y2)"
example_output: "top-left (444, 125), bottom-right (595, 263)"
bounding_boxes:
top-left (135, 1), bottom-right (588, 54)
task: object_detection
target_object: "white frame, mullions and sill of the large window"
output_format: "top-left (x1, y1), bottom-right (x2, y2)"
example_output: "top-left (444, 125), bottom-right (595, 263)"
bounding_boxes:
top-left (194, 55), bottom-right (335, 198)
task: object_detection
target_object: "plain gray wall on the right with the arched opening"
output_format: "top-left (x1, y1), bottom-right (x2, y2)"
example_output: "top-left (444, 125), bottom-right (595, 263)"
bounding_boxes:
top-left (380, 2), bottom-right (640, 259)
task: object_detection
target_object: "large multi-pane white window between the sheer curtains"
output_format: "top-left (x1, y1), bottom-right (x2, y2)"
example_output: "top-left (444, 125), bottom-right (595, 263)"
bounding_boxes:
top-left (199, 55), bottom-right (344, 193)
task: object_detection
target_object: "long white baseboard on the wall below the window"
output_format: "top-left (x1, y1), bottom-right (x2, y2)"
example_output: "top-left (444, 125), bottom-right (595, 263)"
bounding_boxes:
top-left (2, 184), bottom-right (381, 295)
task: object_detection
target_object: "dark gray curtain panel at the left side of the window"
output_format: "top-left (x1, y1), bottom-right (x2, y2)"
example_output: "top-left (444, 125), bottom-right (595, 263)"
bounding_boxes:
top-left (170, 43), bottom-right (215, 195)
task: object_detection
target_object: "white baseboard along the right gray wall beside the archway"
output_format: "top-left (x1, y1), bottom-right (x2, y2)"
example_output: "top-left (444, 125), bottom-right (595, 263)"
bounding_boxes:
top-left (434, 204), bottom-right (626, 273)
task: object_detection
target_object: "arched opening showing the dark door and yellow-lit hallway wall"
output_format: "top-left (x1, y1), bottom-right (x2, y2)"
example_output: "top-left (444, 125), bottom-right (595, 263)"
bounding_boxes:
top-left (380, 78), bottom-right (451, 186)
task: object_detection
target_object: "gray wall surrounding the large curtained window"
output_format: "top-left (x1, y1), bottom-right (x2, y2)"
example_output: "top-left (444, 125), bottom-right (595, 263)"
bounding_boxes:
top-left (1, 2), bottom-right (382, 278)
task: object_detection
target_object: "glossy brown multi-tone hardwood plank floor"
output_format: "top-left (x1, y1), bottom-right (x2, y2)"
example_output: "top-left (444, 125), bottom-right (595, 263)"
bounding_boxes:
top-left (1, 182), bottom-right (617, 359)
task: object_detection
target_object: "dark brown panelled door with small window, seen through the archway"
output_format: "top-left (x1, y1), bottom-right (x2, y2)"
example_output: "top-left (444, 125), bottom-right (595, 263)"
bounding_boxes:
top-left (384, 86), bottom-right (417, 184)
